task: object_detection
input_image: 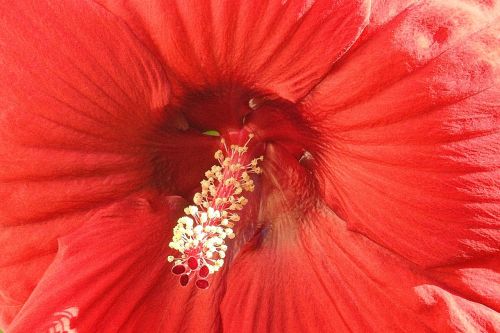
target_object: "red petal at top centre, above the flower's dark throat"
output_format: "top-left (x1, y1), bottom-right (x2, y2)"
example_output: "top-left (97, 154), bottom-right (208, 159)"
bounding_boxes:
top-left (94, 0), bottom-right (369, 100)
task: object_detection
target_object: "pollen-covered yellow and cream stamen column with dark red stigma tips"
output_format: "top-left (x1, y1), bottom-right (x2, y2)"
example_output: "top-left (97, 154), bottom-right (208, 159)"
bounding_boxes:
top-left (168, 134), bottom-right (264, 289)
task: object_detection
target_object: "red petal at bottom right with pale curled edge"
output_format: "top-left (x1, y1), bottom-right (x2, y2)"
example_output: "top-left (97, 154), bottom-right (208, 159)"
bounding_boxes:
top-left (221, 205), bottom-right (500, 332)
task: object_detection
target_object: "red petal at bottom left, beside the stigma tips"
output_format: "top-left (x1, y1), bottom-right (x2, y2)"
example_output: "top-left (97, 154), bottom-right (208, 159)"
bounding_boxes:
top-left (9, 193), bottom-right (189, 333)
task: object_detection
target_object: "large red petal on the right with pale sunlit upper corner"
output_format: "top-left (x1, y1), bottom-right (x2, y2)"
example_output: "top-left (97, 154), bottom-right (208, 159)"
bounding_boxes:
top-left (304, 2), bottom-right (500, 267)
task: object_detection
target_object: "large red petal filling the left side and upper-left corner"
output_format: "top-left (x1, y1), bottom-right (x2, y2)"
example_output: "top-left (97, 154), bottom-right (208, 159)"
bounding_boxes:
top-left (0, 1), bottom-right (168, 322)
